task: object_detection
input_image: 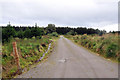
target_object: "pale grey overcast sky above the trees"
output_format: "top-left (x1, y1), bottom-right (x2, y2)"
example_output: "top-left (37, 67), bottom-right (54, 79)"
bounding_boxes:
top-left (0, 0), bottom-right (119, 31)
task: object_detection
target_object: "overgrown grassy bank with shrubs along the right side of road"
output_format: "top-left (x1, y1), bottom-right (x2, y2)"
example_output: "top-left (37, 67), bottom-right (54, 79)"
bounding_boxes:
top-left (65, 33), bottom-right (120, 62)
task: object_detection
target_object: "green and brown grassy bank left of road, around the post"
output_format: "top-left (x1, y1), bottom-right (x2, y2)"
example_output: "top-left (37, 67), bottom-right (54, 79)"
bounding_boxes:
top-left (2, 35), bottom-right (56, 78)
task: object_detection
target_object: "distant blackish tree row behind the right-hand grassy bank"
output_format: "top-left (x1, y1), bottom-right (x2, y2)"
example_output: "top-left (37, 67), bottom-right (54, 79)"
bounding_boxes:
top-left (56, 27), bottom-right (106, 35)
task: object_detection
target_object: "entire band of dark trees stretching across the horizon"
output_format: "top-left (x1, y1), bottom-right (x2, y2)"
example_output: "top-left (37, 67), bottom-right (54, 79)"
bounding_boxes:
top-left (2, 24), bottom-right (118, 42)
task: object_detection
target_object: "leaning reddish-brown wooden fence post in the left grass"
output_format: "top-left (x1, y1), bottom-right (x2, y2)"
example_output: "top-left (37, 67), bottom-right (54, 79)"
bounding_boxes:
top-left (12, 42), bottom-right (22, 73)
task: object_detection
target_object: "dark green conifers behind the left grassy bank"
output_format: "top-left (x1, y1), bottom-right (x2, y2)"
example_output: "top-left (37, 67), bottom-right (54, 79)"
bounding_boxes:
top-left (2, 24), bottom-right (45, 43)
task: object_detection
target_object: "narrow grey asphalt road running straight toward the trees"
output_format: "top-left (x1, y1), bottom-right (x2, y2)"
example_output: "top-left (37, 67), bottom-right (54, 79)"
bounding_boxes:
top-left (17, 36), bottom-right (118, 78)
